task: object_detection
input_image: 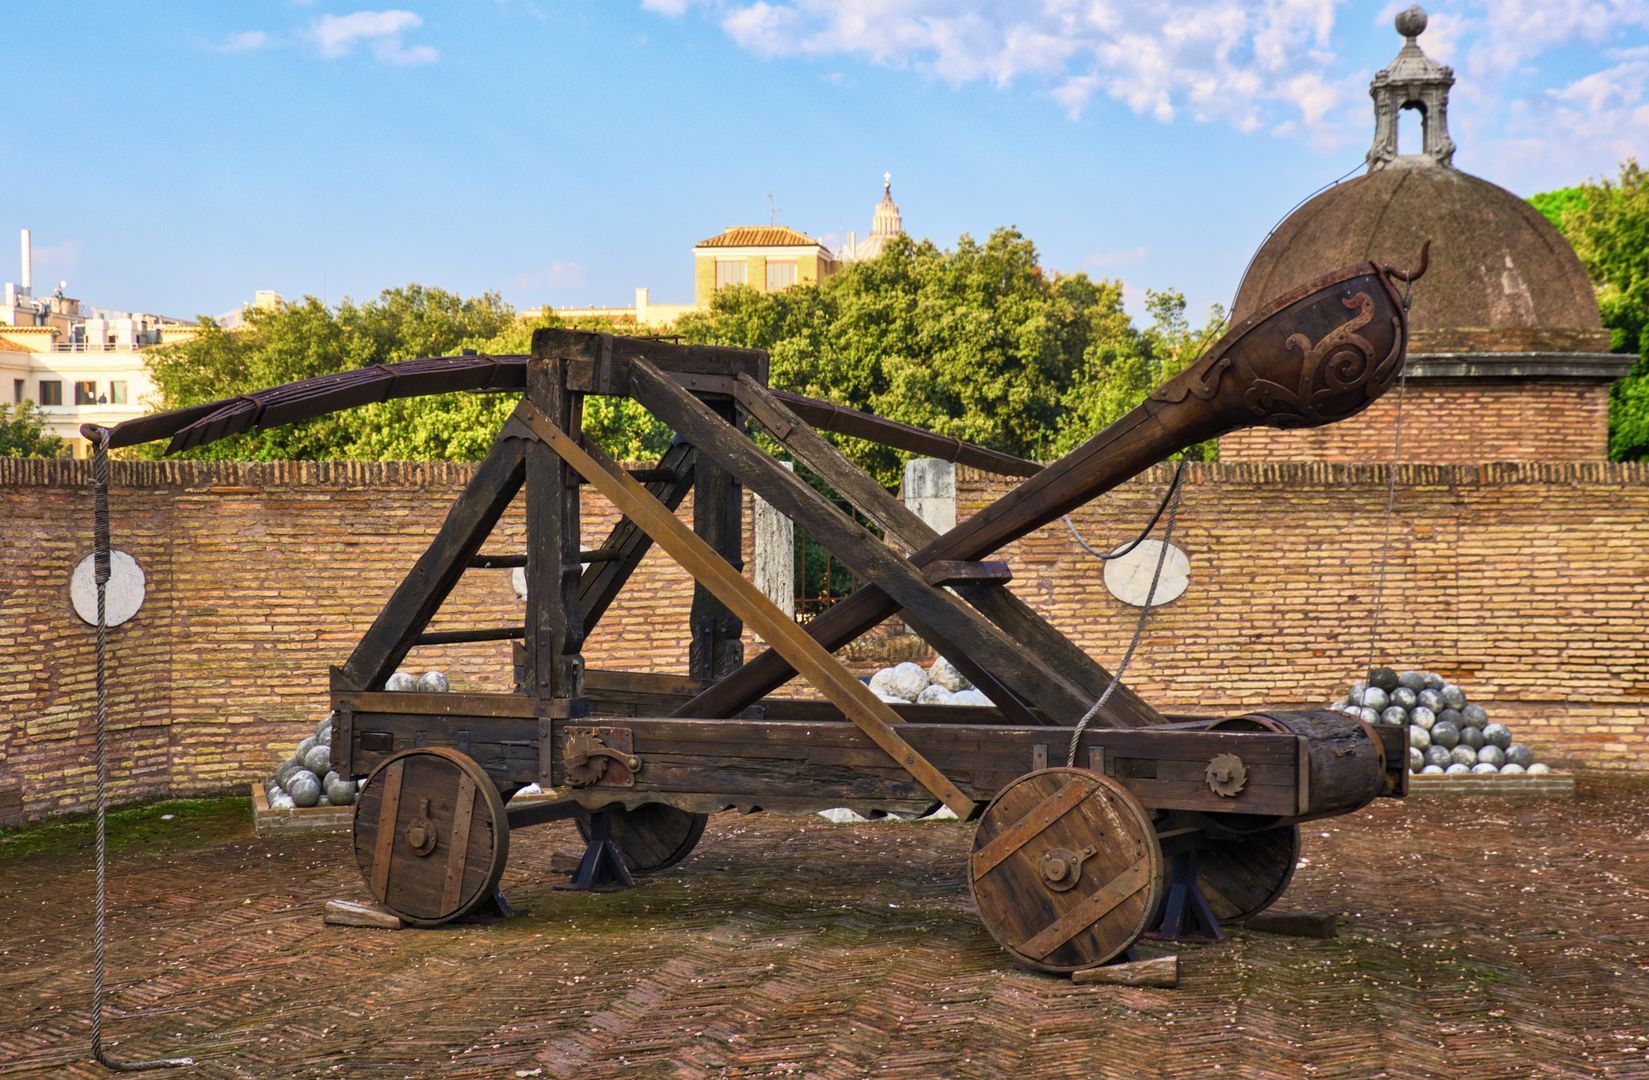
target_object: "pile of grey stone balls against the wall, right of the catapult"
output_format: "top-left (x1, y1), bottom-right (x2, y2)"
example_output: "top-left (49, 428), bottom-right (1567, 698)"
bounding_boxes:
top-left (1332, 668), bottom-right (1552, 777)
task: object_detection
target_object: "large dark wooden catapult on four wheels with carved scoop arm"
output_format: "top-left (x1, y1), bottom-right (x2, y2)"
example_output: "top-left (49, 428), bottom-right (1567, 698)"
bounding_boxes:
top-left (86, 264), bottom-right (1423, 971)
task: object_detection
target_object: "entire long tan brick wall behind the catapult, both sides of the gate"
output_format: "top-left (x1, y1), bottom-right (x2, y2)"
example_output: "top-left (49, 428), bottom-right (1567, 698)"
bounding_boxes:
top-left (0, 458), bottom-right (1649, 816)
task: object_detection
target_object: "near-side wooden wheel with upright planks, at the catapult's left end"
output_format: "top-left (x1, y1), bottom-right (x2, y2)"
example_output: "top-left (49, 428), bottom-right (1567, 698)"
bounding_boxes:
top-left (355, 747), bottom-right (510, 927)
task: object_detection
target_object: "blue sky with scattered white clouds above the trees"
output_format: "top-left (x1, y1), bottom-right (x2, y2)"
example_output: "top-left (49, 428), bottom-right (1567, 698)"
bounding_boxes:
top-left (0, 0), bottom-right (1649, 317)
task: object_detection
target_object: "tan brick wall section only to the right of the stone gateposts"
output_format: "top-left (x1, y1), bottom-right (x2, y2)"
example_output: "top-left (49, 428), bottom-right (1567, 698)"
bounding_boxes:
top-left (958, 462), bottom-right (1649, 772)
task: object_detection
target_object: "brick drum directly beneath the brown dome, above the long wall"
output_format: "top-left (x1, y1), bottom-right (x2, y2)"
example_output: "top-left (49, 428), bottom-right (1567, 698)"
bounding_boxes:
top-left (1220, 379), bottom-right (1609, 463)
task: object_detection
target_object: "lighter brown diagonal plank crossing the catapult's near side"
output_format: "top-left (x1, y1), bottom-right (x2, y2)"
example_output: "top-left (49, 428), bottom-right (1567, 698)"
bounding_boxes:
top-left (516, 401), bottom-right (976, 818)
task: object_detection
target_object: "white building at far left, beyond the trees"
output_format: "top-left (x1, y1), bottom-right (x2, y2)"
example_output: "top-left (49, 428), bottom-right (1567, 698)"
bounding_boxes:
top-left (0, 229), bottom-right (195, 457)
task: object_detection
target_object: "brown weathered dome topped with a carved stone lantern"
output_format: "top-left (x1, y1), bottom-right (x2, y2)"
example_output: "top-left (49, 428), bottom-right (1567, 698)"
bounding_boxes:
top-left (1232, 8), bottom-right (1608, 353)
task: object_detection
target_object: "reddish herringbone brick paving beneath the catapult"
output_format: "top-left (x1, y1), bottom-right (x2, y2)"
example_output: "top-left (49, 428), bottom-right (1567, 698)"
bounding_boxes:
top-left (0, 788), bottom-right (1649, 1077)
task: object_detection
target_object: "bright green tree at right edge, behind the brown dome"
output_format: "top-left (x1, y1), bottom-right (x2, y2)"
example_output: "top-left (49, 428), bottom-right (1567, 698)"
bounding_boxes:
top-left (1530, 158), bottom-right (1649, 462)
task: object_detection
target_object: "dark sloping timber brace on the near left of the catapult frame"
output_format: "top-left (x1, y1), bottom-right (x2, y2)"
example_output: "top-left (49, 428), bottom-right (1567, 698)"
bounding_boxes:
top-left (343, 435), bottom-right (526, 689)
